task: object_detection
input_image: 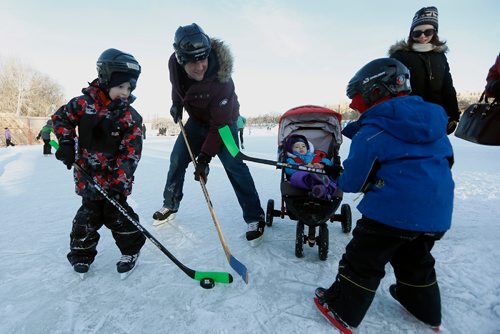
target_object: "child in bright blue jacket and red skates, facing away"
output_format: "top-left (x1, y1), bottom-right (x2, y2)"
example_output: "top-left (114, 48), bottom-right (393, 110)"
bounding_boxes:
top-left (314, 58), bottom-right (454, 333)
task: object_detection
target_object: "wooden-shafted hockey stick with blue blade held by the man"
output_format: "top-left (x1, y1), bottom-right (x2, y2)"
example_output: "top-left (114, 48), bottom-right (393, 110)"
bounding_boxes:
top-left (179, 120), bottom-right (248, 284)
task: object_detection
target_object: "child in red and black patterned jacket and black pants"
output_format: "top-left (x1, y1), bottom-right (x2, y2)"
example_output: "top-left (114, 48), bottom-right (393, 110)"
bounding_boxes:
top-left (52, 49), bottom-right (146, 276)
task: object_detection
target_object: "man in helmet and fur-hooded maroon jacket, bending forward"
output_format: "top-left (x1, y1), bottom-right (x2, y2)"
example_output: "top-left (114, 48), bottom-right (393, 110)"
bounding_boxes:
top-left (153, 23), bottom-right (265, 246)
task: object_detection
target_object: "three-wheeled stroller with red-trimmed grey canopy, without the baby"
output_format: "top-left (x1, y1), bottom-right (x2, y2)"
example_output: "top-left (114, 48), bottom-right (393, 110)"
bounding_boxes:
top-left (266, 105), bottom-right (352, 261)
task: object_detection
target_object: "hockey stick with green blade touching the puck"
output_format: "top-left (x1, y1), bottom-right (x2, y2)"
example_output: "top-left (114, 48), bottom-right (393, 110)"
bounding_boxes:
top-left (50, 141), bottom-right (233, 283)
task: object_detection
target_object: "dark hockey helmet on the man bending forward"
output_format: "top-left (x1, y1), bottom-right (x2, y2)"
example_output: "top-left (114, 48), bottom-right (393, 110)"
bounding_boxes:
top-left (174, 23), bottom-right (212, 65)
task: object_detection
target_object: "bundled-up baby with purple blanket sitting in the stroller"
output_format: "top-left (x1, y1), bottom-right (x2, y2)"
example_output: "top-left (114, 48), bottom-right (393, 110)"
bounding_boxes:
top-left (285, 135), bottom-right (337, 200)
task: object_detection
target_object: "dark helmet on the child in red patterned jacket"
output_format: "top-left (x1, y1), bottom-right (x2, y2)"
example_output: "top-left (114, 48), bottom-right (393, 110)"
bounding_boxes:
top-left (97, 49), bottom-right (141, 88)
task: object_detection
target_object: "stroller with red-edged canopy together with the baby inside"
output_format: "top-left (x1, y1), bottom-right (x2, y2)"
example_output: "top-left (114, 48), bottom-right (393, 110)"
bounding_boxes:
top-left (266, 105), bottom-right (352, 261)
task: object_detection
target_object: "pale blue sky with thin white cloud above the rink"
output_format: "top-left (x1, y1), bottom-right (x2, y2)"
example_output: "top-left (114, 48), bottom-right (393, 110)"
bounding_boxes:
top-left (0, 0), bottom-right (500, 119)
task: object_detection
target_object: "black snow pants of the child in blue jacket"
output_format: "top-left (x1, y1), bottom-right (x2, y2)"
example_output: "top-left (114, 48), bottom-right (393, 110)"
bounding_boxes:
top-left (326, 217), bottom-right (444, 327)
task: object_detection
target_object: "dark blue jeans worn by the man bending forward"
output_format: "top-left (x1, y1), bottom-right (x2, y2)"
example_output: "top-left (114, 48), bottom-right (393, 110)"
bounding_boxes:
top-left (163, 118), bottom-right (264, 223)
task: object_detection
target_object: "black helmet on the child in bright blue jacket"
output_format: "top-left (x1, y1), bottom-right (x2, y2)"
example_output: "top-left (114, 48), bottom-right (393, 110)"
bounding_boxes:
top-left (346, 58), bottom-right (411, 106)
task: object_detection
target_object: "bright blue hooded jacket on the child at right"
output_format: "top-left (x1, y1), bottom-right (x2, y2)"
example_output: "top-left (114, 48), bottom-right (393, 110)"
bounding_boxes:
top-left (338, 96), bottom-right (455, 232)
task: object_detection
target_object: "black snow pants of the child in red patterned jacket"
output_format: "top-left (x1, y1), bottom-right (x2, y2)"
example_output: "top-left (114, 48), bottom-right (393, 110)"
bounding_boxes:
top-left (68, 197), bottom-right (146, 265)
